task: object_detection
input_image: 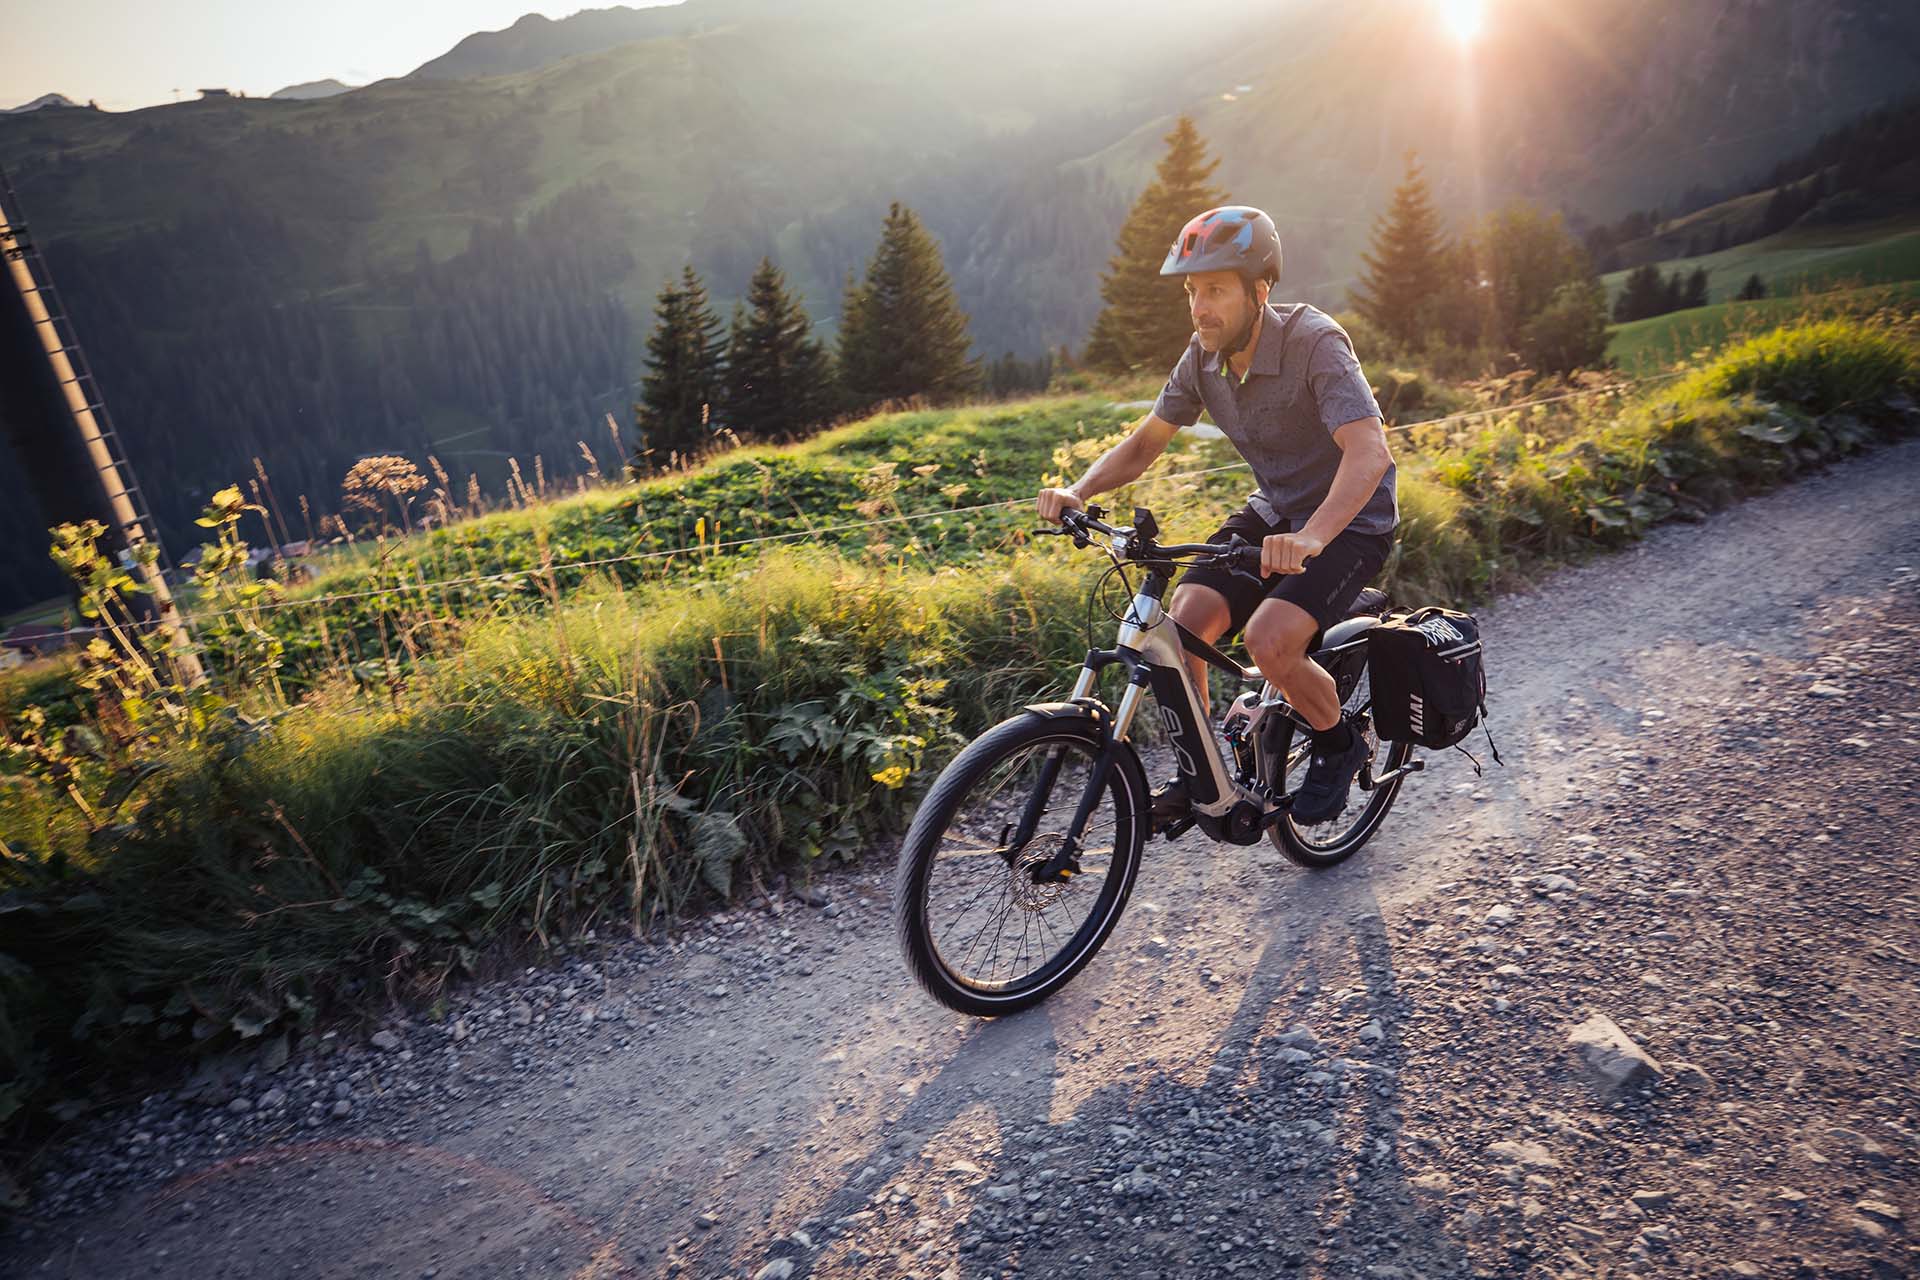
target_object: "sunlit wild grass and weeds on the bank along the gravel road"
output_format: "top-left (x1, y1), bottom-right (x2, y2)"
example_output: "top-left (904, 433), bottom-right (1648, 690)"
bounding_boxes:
top-left (0, 311), bottom-right (1920, 1159)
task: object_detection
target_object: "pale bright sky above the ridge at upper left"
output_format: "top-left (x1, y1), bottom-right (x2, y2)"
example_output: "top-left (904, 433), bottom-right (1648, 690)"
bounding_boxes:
top-left (0, 0), bottom-right (675, 111)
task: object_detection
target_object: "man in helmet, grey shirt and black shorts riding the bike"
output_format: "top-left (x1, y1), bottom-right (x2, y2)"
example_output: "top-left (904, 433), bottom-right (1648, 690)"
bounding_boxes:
top-left (1037, 205), bottom-right (1400, 825)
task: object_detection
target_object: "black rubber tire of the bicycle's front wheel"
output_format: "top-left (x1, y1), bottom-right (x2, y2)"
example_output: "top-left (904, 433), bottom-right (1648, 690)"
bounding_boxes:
top-left (893, 712), bottom-right (1148, 1017)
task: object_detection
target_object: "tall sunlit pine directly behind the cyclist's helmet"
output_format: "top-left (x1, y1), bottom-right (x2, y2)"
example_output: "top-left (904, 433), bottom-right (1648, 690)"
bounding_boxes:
top-left (1083, 115), bottom-right (1227, 372)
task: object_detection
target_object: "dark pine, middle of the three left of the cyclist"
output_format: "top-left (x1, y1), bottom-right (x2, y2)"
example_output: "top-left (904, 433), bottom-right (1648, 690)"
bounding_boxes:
top-left (724, 257), bottom-right (835, 439)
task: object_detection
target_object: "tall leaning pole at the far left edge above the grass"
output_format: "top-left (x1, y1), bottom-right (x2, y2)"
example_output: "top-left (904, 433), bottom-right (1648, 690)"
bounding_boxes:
top-left (0, 169), bottom-right (205, 683)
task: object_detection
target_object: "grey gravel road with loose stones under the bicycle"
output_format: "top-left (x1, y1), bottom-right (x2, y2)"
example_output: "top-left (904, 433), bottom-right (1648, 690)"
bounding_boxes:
top-left (0, 441), bottom-right (1920, 1280)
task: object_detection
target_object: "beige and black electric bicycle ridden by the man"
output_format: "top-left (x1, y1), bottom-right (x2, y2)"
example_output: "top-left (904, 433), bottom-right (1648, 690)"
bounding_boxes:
top-left (893, 507), bottom-right (1425, 1017)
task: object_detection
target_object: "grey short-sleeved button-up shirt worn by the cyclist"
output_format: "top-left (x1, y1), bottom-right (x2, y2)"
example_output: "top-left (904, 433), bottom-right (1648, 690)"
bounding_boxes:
top-left (1154, 301), bottom-right (1400, 533)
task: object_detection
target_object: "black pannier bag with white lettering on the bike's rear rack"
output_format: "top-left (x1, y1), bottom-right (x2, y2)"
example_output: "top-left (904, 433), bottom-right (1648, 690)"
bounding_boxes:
top-left (1367, 604), bottom-right (1500, 760)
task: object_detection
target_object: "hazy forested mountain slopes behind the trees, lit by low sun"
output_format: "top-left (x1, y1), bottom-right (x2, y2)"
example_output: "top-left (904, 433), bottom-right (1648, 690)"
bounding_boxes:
top-left (0, 0), bottom-right (1920, 614)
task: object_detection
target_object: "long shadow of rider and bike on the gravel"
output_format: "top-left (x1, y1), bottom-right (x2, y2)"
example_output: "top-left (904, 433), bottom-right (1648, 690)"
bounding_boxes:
top-left (748, 871), bottom-right (1469, 1276)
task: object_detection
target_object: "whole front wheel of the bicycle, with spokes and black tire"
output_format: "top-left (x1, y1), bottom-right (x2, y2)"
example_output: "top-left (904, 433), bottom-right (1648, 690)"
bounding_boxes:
top-left (893, 712), bottom-right (1148, 1017)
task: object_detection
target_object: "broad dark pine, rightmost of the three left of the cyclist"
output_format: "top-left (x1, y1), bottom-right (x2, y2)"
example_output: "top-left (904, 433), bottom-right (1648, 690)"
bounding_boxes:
top-left (839, 201), bottom-right (979, 405)
